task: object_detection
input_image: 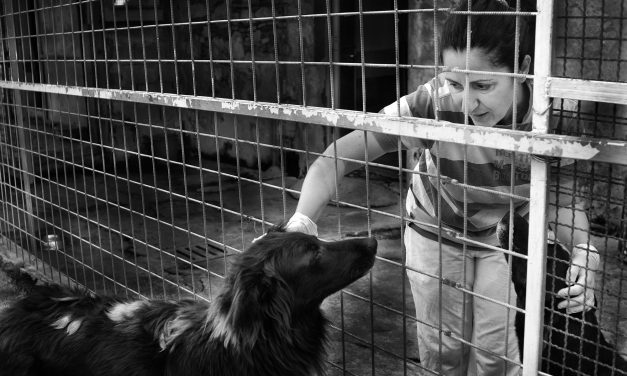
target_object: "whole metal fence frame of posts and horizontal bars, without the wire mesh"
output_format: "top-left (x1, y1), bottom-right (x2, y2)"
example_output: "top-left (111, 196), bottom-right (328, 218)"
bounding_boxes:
top-left (0, 0), bottom-right (627, 376)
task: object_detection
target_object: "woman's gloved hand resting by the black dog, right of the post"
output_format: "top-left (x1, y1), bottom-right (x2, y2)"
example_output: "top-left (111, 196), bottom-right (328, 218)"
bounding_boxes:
top-left (557, 244), bottom-right (600, 314)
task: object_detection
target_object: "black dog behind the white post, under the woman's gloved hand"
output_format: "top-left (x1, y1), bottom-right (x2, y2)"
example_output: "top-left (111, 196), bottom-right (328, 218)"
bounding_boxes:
top-left (497, 213), bottom-right (627, 376)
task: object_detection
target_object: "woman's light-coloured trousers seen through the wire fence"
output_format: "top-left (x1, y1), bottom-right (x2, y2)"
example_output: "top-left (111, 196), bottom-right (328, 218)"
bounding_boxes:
top-left (405, 227), bottom-right (520, 376)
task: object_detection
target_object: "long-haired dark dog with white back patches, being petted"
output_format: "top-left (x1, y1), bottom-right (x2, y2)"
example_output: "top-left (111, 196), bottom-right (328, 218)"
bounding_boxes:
top-left (0, 227), bottom-right (377, 376)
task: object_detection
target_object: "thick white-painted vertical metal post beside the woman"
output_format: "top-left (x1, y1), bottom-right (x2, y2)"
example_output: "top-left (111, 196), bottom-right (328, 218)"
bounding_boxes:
top-left (523, 0), bottom-right (553, 376)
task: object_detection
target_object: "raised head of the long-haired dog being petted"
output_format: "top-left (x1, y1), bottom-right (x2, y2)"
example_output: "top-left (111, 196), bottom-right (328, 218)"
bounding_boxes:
top-left (213, 227), bottom-right (377, 346)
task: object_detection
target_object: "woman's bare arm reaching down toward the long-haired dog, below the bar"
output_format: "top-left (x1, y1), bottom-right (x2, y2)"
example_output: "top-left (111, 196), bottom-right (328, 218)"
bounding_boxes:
top-left (296, 130), bottom-right (397, 222)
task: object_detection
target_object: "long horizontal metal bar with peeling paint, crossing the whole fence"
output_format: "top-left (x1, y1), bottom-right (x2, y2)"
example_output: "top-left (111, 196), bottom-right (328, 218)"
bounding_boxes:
top-left (0, 81), bottom-right (627, 165)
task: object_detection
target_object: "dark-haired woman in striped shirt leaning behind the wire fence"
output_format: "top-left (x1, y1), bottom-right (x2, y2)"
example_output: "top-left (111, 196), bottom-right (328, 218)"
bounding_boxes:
top-left (287, 0), bottom-right (599, 375)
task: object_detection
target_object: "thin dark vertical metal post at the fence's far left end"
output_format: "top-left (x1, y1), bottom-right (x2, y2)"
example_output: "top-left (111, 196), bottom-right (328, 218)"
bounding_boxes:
top-left (5, 0), bottom-right (37, 252)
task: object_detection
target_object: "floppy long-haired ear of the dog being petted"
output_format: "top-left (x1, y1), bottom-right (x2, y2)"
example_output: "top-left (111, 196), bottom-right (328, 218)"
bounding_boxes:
top-left (212, 270), bottom-right (292, 348)
